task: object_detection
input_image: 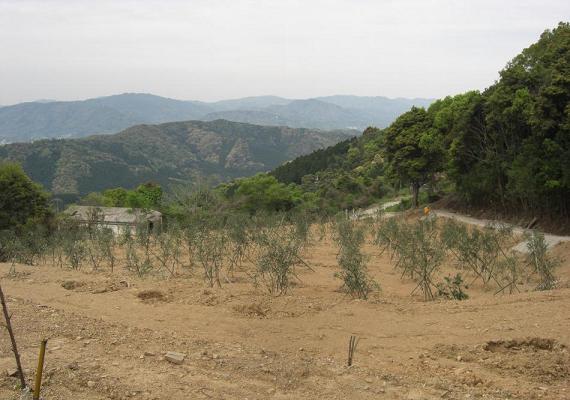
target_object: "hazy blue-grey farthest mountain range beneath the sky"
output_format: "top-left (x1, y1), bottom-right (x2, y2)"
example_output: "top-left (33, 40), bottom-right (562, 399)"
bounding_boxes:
top-left (0, 93), bottom-right (432, 143)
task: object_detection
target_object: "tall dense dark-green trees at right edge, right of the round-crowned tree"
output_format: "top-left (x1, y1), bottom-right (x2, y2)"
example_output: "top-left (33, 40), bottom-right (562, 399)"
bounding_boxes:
top-left (451, 23), bottom-right (570, 212)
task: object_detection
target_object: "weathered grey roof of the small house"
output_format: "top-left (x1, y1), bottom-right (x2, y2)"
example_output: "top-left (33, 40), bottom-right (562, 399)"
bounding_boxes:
top-left (64, 206), bottom-right (162, 224)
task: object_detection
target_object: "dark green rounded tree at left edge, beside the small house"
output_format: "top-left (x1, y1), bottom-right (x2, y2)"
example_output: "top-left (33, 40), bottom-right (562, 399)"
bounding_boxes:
top-left (0, 163), bottom-right (51, 230)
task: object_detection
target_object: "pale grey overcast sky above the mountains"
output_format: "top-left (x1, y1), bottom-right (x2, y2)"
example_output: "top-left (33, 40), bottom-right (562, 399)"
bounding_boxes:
top-left (0, 0), bottom-right (570, 105)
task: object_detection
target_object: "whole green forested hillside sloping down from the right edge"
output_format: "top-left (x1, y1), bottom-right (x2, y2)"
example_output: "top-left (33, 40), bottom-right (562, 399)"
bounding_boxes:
top-left (262, 23), bottom-right (570, 217)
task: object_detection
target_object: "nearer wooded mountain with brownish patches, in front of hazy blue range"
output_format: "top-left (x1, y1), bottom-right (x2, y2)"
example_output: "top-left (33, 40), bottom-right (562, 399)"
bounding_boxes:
top-left (0, 120), bottom-right (350, 195)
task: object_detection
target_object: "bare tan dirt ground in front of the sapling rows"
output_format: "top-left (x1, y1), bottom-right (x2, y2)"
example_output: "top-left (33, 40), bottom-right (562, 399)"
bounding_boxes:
top-left (0, 227), bottom-right (570, 400)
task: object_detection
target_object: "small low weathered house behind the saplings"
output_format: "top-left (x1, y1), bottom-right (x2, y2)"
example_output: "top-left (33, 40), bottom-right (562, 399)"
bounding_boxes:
top-left (64, 206), bottom-right (162, 235)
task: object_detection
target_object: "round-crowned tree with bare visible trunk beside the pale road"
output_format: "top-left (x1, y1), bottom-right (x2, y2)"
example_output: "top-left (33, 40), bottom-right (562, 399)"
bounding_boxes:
top-left (383, 107), bottom-right (443, 207)
